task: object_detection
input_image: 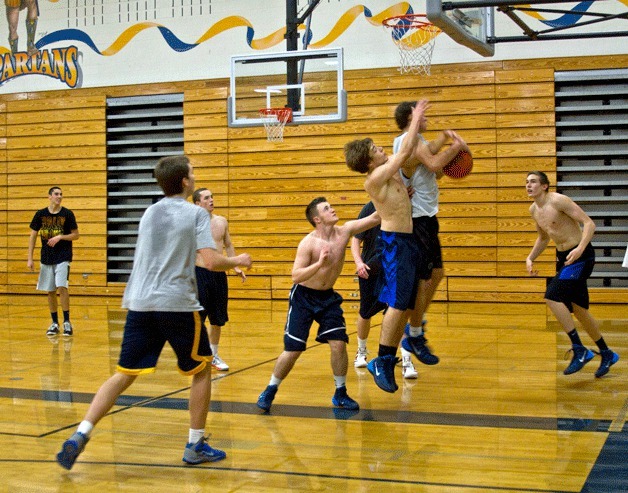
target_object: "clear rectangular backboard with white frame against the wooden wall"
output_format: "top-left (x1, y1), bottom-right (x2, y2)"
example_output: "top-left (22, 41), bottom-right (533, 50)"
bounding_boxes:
top-left (227, 48), bottom-right (347, 127)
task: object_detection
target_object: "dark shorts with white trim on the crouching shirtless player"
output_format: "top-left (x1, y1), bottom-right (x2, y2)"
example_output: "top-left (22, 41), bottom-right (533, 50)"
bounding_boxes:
top-left (283, 284), bottom-right (349, 351)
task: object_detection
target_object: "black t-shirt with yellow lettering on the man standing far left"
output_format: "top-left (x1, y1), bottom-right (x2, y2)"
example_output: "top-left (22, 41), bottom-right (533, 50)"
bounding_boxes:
top-left (30, 207), bottom-right (78, 265)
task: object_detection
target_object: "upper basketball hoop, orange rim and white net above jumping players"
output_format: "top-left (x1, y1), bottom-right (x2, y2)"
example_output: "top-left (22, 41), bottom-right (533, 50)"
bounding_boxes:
top-left (382, 14), bottom-right (441, 75)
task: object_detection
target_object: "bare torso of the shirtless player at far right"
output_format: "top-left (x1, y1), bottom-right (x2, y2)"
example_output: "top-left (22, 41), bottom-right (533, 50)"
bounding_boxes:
top-left (530, 192), bottom-right (584, 252)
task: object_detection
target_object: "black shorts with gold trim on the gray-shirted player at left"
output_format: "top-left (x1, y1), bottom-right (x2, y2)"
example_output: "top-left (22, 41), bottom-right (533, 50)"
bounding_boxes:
top-left (117, 310), bottom-right (212, 375)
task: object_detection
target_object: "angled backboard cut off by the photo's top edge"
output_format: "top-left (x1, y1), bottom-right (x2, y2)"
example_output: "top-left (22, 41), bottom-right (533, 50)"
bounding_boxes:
top-left (426, 0), bottom-right (495, 57)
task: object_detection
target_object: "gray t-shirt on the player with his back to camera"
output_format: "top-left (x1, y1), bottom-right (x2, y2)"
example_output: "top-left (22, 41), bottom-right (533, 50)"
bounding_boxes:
top-left (122, 197), bottom-right (216, 312)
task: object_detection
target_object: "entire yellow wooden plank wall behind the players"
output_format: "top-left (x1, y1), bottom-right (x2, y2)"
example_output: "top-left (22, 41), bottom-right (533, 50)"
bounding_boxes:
top-left (0, 56), bottom-right (628, 311)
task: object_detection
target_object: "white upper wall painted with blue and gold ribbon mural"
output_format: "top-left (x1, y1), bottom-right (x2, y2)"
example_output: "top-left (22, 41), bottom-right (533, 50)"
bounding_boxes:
top-left (0, 0), bottom-right (628, 92)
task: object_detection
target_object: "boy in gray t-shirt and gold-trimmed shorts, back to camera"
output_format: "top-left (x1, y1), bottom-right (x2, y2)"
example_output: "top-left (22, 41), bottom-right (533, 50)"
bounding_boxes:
top-left (57, 156), bottom-right (251, 469)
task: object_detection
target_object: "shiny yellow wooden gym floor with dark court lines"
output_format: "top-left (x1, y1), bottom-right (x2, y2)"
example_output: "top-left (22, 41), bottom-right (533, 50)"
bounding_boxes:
top-left (0, 295), bottom-right (628, 493)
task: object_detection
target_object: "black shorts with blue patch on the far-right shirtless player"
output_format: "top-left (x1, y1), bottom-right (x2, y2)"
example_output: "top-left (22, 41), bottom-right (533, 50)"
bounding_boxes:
top-left (545, 243), bottom-right (595, 312)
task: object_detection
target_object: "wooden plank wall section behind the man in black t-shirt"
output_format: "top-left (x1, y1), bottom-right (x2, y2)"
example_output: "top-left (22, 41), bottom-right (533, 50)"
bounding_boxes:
top-left (3, 92), bottom-right (107, 293)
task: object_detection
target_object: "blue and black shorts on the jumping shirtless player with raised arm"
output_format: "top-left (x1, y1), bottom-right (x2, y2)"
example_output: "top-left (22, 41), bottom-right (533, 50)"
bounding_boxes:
top-left (377, 231), bottom-right (420, 310)
